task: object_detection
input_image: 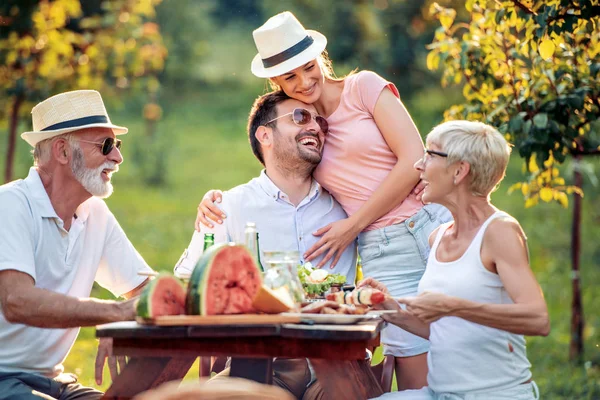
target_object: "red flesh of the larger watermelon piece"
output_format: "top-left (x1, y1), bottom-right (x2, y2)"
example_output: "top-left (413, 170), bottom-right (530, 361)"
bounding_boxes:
top-left (196, 246), bottom-right (261, 315)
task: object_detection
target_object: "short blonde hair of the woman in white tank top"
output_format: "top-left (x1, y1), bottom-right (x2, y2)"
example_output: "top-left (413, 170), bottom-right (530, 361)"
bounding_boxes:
top-left (427, 121), bottom-right (511, 196)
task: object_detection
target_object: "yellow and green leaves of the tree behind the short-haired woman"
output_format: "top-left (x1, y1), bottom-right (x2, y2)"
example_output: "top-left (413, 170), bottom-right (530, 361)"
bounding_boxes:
top-left (427, 0), bottom-right (600, 207)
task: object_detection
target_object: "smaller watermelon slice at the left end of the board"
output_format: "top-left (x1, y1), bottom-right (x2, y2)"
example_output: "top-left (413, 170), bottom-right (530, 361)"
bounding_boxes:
top-left (137, 274), bottom-right (185, 318)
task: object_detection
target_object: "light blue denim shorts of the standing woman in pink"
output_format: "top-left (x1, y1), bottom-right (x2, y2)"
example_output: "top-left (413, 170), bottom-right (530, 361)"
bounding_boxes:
top-left (358, 204), bottom-right (452, 357)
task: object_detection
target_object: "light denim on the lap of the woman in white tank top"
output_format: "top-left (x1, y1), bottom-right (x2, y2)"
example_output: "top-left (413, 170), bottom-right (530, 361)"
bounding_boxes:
top-left (377, 381), bottom-right (540, 400)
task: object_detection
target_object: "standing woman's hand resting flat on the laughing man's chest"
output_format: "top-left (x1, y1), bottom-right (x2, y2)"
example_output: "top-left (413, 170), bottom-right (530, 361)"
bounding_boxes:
top-left (304, 218), bottom-right (361, 268)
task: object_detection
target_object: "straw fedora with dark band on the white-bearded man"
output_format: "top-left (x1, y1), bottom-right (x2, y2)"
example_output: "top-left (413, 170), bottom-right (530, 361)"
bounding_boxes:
top-left (21, 90), bottom-right (127, 147)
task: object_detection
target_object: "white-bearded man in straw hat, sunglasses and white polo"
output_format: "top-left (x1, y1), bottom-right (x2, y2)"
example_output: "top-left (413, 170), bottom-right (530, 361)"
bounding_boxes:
top-left (0, 90), bottom-right (157, 399)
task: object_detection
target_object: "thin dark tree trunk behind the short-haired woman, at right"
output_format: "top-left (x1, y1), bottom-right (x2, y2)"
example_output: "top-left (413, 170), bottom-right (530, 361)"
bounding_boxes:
top-left (569, 156), bottom-right (584, 361)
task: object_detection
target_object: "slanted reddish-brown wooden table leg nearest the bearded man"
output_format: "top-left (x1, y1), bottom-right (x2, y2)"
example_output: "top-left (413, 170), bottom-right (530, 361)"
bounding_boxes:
top-left (103, 357), bottom-right (196, 400)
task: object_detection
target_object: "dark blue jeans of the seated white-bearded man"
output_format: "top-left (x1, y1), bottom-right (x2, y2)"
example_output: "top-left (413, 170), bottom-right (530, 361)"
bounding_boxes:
top-left (0, 372), bottom-right (102, 400)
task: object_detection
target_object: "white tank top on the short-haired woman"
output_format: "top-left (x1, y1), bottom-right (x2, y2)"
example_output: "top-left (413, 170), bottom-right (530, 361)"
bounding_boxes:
top-left (418, 211), bottom-right (531, 393)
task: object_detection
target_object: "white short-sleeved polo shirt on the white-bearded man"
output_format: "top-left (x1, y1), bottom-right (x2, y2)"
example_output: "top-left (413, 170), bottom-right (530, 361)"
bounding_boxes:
top-left (0, 168), bottom-right (151, 377)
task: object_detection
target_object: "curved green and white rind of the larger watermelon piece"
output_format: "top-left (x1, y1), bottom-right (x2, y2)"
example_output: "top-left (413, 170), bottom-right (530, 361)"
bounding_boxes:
top-left (185, 243), bottom-right (260, 315)
